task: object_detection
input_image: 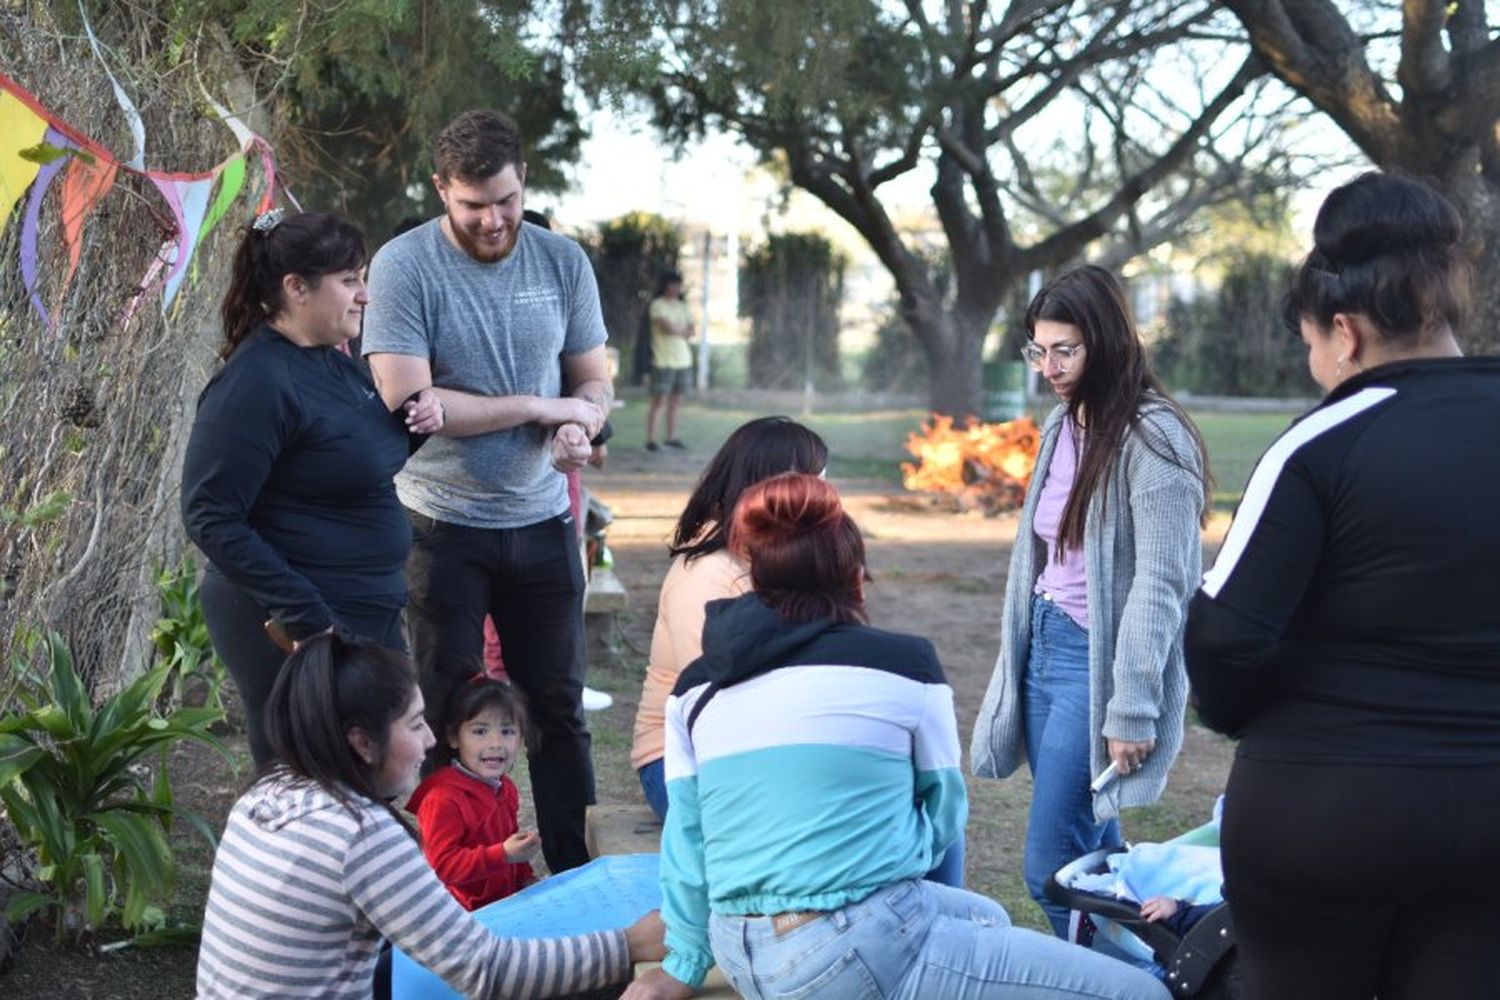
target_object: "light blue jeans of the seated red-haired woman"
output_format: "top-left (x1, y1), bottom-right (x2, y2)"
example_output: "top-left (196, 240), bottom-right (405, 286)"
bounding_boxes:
top-left (708, 880), bottom-right (1170, 1000)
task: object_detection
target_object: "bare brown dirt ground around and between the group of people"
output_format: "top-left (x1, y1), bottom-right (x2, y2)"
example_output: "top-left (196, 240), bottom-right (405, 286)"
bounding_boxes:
top-left (0, 453), bottom-right (1230, 1000)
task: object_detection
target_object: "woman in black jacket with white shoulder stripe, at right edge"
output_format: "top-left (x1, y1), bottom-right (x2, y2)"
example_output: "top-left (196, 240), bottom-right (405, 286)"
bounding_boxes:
top-left (1187, 174), bottom-right (1500, 1000)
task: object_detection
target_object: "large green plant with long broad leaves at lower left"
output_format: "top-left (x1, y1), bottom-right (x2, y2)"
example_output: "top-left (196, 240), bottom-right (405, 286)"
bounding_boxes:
top-left (0, 634), bottom-right (230, 940)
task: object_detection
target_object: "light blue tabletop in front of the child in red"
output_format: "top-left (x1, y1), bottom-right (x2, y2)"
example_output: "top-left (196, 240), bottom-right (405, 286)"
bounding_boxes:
top-left (390, 855), bottom-right (662, 1000)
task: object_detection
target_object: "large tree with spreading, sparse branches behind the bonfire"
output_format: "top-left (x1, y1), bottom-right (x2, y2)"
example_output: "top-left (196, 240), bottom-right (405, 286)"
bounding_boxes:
top-left (579, 0), bottom-right (1283, 415)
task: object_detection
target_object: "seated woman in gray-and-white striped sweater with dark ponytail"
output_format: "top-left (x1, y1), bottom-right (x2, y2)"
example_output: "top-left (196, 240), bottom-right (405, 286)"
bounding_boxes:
top-left (198, 634), bottom-right (662, 999)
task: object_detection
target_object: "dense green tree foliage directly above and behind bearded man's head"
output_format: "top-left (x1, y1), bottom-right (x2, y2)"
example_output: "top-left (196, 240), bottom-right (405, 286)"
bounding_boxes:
top-left (136, 0), bottom-right (585, 243)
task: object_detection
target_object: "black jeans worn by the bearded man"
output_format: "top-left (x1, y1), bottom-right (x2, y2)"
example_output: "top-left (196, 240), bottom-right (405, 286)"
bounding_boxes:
top-left (407, 510), bottom-right (594, 873)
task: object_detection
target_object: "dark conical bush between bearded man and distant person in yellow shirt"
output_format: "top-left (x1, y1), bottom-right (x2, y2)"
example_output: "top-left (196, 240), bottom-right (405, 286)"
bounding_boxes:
top-left (585, 211), bottom-right (683, 381)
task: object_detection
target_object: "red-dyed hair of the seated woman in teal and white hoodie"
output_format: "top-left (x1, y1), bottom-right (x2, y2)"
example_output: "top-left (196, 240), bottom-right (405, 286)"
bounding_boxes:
top-left (729, 472), bottom-right (866, 622)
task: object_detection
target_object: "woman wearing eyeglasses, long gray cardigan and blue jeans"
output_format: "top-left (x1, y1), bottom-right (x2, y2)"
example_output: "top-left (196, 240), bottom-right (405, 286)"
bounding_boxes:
top-left (971, 265), bottom-right (1209, 937)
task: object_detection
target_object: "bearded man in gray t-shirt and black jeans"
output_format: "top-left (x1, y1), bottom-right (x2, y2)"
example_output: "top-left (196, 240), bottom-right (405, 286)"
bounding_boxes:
top-left (363, 111), bottom-right (612, 871)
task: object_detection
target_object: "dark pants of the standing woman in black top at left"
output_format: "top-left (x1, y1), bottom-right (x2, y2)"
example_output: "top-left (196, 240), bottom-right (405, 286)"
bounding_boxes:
top-left (198, 565), bottom-right (407, 774)
